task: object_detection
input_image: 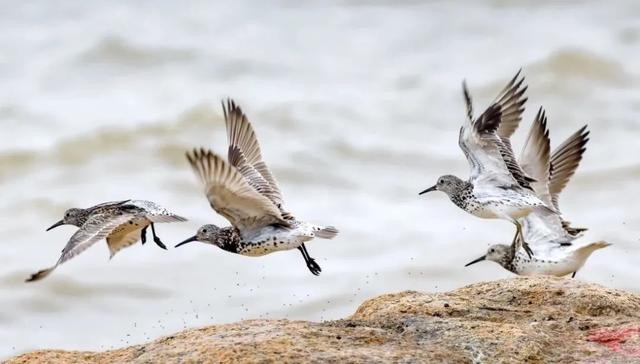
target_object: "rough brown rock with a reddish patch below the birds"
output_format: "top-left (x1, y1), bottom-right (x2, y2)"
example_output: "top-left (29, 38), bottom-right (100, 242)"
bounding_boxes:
top-left (8, 277), bottom-right (640, 363)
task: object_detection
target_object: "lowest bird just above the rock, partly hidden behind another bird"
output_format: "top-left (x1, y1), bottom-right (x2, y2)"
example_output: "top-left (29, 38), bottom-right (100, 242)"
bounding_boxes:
top-left (466, 108), bottom-right (611, 277)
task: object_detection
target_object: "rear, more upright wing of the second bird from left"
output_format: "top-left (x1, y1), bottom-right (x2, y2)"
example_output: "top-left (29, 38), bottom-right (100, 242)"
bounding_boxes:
top-left (222, 99), bottom-right (282, 206)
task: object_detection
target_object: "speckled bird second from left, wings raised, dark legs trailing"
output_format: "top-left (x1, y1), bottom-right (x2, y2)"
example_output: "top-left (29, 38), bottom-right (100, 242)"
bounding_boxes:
top-left (176, 99), bottom-right (338, 275)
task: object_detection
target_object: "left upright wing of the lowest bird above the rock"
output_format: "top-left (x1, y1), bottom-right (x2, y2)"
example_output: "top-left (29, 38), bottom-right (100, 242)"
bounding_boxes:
top-left (519, 107), bottom-right (551, 206)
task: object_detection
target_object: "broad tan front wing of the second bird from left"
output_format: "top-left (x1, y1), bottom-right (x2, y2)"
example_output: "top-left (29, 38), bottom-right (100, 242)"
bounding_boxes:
top-left (187, 149), bottom-right (289, 231)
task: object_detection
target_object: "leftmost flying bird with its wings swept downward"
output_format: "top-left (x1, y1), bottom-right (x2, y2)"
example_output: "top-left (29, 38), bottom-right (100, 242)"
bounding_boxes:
top-left (26, 200), bottom-right (187, 282)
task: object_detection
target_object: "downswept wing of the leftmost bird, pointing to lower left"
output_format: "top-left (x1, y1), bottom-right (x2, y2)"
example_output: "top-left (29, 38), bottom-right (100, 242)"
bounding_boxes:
top-left (27, 213), bottom-right (135, 282)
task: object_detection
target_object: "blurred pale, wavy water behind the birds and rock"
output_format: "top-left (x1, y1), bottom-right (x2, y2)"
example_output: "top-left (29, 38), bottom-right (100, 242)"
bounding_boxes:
top-left (0, 0), bottom-right (640, 358)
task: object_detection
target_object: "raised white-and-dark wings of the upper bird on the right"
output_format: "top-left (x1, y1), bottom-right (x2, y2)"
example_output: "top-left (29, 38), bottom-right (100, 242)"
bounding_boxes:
top-left (458, 74), bottom-right (533, 189)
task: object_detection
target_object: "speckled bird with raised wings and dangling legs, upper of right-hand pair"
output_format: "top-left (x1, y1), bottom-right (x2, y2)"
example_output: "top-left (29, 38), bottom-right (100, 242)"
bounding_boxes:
top-left (419, 70), bottom-right (555, 255)
